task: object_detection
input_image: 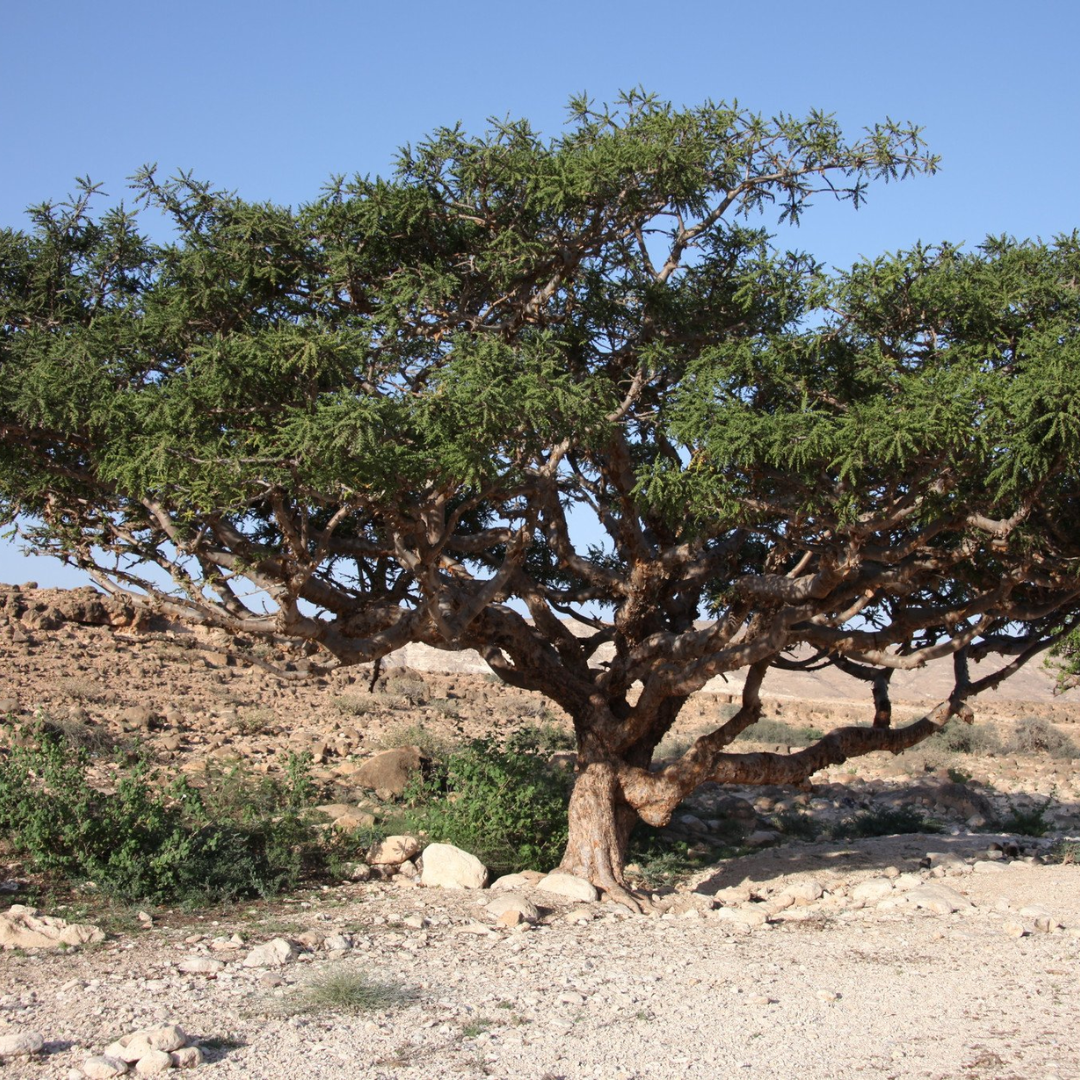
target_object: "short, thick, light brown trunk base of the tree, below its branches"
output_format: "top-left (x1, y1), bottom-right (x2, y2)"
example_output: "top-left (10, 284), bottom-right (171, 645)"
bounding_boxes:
top-left (559, 761), bottom-right (637, 899)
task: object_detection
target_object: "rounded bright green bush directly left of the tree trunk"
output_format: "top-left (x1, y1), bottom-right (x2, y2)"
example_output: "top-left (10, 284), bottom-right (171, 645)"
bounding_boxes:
top-left (405, 730), bottom-right (572, 875)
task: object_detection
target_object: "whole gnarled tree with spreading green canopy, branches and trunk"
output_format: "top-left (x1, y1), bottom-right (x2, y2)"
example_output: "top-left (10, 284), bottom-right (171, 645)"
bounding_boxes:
top-left (0, 92), bottom-right (1080, 892)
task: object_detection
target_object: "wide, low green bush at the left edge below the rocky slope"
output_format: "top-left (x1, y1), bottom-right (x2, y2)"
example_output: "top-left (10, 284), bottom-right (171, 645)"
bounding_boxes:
top-left (0, 728), bottom-right (343, 904)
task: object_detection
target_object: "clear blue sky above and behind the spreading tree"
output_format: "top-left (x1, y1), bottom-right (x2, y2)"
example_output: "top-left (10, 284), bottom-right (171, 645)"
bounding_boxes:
top-left (0, 0), bottom-right (1080, 584)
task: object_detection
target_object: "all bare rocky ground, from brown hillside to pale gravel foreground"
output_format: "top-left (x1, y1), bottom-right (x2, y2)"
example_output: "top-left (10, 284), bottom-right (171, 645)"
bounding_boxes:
top-left (0, 589), bottom-right (1080, 1080)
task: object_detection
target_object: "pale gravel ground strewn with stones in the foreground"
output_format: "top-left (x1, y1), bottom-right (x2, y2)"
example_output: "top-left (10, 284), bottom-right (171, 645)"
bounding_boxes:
top-left (0, 836), bottom-right (1080, 1080)
